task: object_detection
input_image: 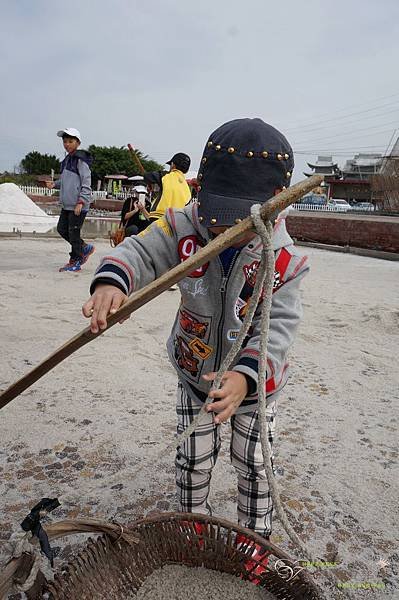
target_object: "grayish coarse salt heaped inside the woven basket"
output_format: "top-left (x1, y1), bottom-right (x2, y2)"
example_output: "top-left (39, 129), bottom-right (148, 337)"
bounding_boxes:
top-left (131, 565), bottom-right (275, 600)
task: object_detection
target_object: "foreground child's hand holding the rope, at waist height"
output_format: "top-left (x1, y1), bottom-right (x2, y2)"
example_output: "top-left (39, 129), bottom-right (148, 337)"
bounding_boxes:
top-left (203, 371), bottom-right (248, 423)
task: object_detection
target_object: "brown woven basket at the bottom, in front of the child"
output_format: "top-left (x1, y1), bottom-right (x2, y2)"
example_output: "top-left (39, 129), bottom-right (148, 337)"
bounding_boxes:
top-left (36, 513), bottom-right (324, 600)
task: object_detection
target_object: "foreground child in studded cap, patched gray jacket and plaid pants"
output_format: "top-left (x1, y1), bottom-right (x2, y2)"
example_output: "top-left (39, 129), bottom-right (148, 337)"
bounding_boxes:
top-left (83, 119), bottom-right (308, 556)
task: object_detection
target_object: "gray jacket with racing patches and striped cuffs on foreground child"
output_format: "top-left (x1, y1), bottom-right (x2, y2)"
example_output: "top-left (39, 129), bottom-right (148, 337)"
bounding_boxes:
top-left (91, 203), bottom-right (308, 413)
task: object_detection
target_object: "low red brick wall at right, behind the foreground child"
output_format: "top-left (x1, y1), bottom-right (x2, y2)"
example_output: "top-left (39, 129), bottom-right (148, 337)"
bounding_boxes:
top-left (286, 213), bottom-right (399, 252)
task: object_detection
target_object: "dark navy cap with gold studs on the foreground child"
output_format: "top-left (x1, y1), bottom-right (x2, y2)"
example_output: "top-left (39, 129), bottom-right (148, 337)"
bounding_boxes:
top-left (197, 119), bottom-right (294, 227)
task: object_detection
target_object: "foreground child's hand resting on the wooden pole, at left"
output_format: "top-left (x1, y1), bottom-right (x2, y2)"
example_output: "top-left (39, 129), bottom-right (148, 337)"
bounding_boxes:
top-left (82, 284), bottom-right (128, 333)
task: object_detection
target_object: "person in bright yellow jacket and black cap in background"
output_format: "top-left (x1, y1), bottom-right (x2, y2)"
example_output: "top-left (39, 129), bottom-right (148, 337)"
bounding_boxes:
top-left (148, 152), bottom-right (191, 220)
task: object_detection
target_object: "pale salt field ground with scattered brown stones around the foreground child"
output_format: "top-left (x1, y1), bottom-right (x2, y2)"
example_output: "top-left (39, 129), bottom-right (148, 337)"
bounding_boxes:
top-left (0, 237), bottom-right (399, 600)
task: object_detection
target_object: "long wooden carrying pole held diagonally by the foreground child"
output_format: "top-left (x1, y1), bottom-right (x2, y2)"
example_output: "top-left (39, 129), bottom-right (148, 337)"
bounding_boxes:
top-left (0, 175), bottom-right (323, 409)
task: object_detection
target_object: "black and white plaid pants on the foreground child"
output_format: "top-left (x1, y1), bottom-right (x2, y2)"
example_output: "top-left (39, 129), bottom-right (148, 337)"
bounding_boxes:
top-left (175, 383), bottom-right (276, 537)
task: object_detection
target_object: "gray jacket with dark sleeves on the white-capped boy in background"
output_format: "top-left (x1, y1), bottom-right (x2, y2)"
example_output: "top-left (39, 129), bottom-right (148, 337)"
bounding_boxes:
top-left (54, 150), bottom-right (92, 212)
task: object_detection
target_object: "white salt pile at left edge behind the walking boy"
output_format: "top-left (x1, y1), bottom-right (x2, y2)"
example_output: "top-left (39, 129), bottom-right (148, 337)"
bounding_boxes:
top-left (0, 183), bottom-right (57, 231)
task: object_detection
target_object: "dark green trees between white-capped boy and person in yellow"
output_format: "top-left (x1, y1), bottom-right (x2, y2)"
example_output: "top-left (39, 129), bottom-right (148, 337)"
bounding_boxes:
top-left (88, 144), bottom-right (162, 182)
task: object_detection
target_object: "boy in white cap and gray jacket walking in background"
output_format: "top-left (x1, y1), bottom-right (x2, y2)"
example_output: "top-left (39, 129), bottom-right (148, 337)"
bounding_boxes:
top-left (47, 127), bottom-right (95, 271)
